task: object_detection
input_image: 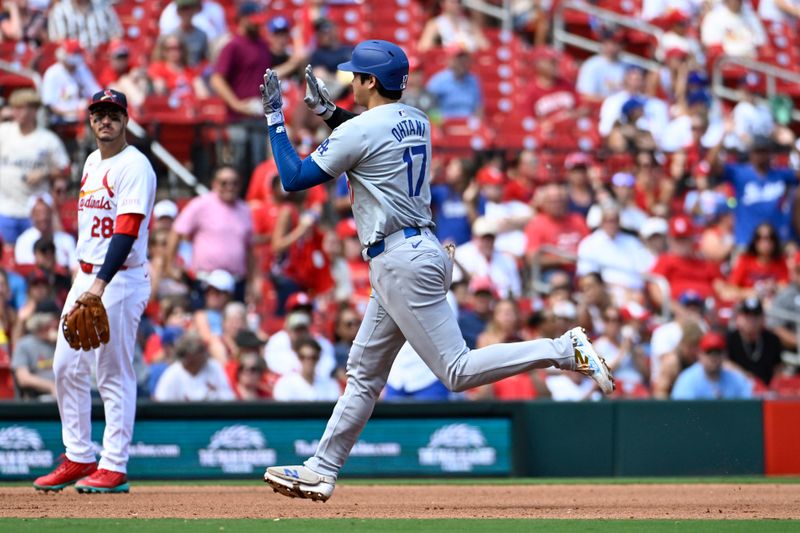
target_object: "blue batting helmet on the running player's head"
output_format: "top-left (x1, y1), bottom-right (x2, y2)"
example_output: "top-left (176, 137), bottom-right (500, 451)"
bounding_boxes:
top-left (339, 40), bottom-right (408, 91)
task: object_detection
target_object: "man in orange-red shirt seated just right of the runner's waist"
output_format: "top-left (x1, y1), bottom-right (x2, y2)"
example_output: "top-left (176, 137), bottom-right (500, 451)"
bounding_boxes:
top-left (525, 183), bottom-right (589, 273)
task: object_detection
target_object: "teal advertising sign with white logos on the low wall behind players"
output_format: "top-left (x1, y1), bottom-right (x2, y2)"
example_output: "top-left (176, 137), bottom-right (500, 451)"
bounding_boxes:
top-left (0, 418), bottom-right (511, 480)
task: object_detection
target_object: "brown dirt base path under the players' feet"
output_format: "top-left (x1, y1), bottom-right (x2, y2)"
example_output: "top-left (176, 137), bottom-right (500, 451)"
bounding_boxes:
top-left (0, 484), bottom-right (800, 519)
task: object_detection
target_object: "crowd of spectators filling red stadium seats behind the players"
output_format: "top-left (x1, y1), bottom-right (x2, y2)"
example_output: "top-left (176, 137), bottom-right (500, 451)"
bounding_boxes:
top-left (0, 0), bottom-right (800, 401)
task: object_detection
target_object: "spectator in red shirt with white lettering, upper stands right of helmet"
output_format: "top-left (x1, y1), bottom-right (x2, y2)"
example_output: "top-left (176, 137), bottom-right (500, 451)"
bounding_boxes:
top-left (525, 46), bottom-right (580, 121)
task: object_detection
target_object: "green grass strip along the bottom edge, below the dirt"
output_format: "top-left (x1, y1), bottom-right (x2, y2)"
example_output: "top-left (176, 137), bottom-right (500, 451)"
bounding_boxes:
top-left (0, 519), bottom-right (800, 533)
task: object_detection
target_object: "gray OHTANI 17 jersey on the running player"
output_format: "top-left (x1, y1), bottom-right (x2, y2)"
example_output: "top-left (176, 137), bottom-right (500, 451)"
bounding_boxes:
top-left (311, 103), bottom-right (434, 246)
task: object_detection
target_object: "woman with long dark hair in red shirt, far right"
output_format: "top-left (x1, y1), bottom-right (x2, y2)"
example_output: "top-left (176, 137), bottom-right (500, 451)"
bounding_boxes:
top-left (728, 222), bottom-right (789, 300)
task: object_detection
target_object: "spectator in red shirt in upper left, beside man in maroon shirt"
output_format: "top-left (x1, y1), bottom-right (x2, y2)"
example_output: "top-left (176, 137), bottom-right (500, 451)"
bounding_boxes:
top-left (147, 35), bottom-right (209, 101)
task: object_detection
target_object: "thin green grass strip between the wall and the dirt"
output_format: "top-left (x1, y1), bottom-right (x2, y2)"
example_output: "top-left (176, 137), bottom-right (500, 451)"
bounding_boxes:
top-left (0, 476), bottom-right (800, 488)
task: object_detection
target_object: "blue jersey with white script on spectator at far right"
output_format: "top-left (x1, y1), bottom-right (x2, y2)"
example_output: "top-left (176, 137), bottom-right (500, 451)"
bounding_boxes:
top-left (723, 163), bottom-right (797, 246)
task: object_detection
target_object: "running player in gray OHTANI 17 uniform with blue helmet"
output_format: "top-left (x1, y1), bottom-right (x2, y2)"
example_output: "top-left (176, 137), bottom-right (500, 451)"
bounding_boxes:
top-left (261, 40), bottom-right (614, 501)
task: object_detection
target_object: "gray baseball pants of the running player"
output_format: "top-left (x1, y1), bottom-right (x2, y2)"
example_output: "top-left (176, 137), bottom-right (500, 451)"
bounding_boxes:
top-left (305, 229), bottom-right (575, 478)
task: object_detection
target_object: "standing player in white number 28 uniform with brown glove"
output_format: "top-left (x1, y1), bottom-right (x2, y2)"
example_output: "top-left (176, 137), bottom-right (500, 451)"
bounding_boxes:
top-left (33, 90), bottom-right (156, 492)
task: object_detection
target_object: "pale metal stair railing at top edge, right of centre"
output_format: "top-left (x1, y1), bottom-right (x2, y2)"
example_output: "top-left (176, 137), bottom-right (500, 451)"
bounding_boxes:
top-left (553, 0), bottom-right (664, 70)
